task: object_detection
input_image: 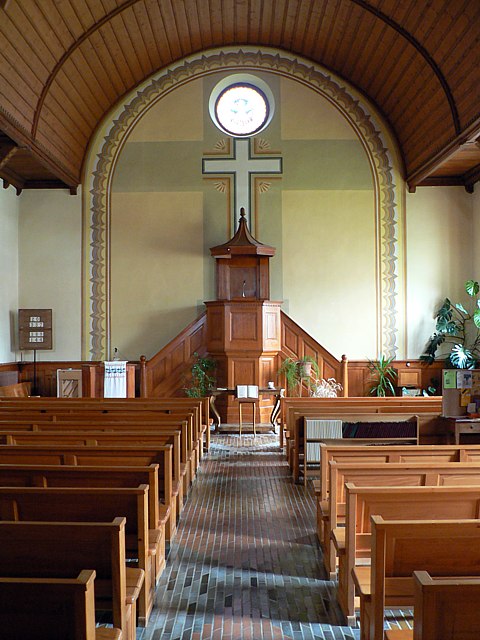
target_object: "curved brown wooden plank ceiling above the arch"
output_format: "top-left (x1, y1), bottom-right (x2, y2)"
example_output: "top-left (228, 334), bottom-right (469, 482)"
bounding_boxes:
top-left (0, 0), bottom-right (480, 191)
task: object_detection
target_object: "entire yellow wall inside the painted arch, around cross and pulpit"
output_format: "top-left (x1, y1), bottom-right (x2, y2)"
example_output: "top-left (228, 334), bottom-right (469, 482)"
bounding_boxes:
top-left (110, 72), bottom-right (376, 358)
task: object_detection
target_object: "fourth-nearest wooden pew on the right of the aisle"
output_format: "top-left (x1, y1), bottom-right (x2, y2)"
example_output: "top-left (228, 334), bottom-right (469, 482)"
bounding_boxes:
top-left (317, 460), bottom-right (480, 580)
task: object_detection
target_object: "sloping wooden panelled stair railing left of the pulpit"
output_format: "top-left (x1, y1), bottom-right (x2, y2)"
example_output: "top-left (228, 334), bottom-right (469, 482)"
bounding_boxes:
top-left (140, 313), bottom-right (207, 398)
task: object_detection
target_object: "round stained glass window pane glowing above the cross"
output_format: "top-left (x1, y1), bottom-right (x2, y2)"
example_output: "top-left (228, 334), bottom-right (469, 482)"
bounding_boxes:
top-left (215, 84), bottom-right (269, 136)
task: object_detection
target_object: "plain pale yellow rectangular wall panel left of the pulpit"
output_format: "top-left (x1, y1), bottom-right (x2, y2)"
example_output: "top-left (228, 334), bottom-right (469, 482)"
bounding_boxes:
top-left (111, 192), bottom-right (203, 360)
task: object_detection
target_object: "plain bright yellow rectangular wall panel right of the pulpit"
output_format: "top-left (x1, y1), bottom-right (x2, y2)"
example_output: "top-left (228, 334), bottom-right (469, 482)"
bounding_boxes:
top-left (282, 191), bottom-right (376, 359)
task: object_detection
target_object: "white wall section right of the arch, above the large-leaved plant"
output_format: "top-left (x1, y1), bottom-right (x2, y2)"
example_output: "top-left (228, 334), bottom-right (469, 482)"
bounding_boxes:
top-left (406, 187), bottom-right (474, 359)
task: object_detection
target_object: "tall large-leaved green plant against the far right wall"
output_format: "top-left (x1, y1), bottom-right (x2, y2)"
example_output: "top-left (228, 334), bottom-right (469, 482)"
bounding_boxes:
top-left (420, 280), bottom-right (480, 369)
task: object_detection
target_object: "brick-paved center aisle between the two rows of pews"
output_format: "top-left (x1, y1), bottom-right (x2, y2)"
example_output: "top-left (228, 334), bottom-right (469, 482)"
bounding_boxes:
top-left (138, 435), bottom-right (359, 640)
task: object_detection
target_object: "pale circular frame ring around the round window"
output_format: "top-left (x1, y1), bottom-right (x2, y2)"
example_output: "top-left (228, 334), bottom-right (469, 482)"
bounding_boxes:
top-left (208, 73), bottom-right (275, 138)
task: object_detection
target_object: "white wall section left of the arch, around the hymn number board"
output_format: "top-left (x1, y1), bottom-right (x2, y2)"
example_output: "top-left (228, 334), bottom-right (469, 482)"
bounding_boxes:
top-left (18, 190), bottom-right (82, 360)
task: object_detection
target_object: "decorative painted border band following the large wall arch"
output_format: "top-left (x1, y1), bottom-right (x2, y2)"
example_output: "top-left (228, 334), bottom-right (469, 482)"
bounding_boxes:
top-left (82, 47), bottom-right (404, 360)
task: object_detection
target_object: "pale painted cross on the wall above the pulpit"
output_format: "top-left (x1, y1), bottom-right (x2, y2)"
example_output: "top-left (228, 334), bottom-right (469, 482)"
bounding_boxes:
top-left (202, 138), bottom-right (282, 229)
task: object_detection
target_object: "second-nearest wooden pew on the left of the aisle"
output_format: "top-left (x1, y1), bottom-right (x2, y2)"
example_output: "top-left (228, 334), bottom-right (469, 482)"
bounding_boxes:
top-left (0, 518), bottom-right (144, 640)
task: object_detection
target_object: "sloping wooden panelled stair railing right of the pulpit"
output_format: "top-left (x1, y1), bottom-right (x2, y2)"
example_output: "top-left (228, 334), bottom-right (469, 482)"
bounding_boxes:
top-left (278, 311), bottom-right (348, 396)
